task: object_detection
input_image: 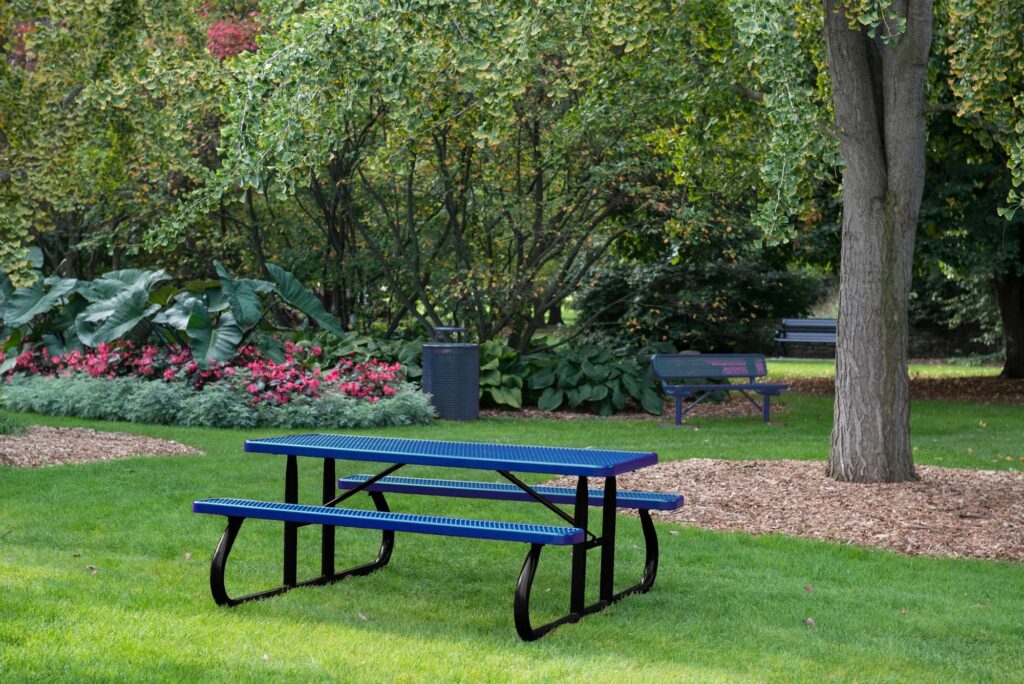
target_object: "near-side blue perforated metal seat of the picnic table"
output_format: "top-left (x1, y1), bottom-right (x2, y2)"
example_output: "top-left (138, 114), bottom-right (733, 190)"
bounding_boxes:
top-left (193, 499), bottom-right (584, 546)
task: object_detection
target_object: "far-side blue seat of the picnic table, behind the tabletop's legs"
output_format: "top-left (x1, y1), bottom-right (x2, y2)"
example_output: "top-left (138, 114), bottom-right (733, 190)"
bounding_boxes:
top-left (338, 475), bottom-right (683, 511)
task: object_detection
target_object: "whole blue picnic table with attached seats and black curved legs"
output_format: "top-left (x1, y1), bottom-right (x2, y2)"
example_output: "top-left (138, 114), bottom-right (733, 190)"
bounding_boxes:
top-left (193, 434), bottom-right (683, 641)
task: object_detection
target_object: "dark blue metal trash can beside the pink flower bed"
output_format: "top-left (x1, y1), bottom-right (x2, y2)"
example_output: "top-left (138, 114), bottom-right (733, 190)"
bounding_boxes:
top-left (423, 328), bottom-right (480, 421)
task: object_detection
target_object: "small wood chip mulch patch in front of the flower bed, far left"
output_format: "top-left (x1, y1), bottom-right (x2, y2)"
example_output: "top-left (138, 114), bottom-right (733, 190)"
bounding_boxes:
top-left (0, 425), bottom-right (203, 468)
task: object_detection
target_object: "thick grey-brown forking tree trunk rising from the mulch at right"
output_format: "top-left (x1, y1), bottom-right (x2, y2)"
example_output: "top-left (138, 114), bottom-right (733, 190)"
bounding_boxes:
top-left (824, 0), bottom-right (933, 482)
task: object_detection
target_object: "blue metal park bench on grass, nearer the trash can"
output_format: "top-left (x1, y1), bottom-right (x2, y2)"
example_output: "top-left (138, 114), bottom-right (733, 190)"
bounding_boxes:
top-left (650, 354), bottom-right (790, 426)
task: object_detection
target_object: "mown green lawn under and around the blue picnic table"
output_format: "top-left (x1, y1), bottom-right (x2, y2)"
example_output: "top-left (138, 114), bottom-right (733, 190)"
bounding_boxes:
top-left (0, 395), bottom-right (1024, 682)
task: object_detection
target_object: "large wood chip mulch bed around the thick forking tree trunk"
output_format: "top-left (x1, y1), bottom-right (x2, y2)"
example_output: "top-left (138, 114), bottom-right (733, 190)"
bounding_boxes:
top-left (553, 459), bottom-right (1024, 562)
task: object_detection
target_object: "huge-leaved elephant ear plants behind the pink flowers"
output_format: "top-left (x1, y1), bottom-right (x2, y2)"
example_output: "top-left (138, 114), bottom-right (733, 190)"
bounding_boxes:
top-left (0, 262), bottom-right (345, 374)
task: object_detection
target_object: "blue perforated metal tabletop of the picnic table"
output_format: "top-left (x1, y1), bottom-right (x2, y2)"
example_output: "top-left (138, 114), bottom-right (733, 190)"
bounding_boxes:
top-left (245, 434), bottom-right (657, 477)
